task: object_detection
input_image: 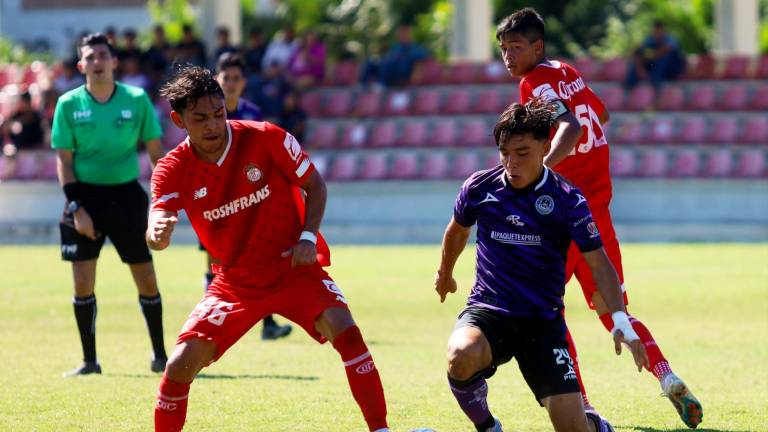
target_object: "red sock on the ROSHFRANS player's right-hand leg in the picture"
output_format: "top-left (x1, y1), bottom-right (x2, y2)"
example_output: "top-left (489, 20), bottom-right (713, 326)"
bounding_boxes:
top-left (333, 326), bottom-right (387, 431)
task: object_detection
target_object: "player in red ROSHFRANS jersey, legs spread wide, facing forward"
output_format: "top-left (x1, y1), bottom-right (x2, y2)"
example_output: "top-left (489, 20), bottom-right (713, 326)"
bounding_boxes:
top-left (146, 67), bottom-right (389, 432)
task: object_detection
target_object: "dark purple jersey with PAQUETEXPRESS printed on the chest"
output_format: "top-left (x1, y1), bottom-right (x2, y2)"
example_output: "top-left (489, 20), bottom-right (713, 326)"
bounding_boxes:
top-left (454, 165), bottom-right (602, 319)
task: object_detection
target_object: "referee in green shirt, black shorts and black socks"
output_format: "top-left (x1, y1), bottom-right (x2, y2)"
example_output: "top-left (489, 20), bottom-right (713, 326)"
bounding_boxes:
top-left (51, 34), bottom-right (167, 376)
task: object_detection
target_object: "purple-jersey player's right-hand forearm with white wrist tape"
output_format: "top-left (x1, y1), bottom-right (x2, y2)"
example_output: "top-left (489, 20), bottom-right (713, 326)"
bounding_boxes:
top-left (582, 248), bottom-right (648, 372)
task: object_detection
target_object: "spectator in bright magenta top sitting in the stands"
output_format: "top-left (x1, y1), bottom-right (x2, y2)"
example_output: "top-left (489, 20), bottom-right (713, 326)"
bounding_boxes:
top-left (286, 30), bottom-right (325, 89)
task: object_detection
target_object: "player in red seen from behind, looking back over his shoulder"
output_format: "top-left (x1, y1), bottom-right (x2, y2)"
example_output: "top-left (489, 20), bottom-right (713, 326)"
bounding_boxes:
top-left (496, 8), bottom-right (702, 428)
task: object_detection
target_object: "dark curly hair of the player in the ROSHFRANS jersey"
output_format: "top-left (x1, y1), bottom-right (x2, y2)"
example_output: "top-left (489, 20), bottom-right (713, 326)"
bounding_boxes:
top-left (160, 65), bottom-right (224, 113)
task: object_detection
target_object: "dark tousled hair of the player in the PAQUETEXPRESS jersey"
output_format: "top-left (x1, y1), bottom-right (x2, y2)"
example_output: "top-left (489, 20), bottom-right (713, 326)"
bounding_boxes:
top-left (493, 96), bottom-right (556, 147)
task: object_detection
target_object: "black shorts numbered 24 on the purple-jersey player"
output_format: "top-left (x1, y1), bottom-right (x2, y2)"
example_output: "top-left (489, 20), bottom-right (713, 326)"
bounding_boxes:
top-left (455, 306), bottom-right (580, 403)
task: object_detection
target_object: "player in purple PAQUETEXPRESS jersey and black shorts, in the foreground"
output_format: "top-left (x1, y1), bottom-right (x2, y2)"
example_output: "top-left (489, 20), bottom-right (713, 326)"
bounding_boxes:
top-left (435, 98), bottom-right (648, 432)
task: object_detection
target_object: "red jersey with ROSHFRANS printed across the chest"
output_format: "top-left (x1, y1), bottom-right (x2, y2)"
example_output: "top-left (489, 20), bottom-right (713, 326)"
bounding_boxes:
top-left (152, 120), bottom-right (327, 287)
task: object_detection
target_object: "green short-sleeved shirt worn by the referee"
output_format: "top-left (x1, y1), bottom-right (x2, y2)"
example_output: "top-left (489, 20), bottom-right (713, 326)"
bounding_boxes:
top-left (51, 82), bottom-right (162, 185)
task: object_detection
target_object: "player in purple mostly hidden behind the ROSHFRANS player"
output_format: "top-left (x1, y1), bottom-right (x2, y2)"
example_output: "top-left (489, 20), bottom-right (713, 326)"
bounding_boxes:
top-left (207, 53), bottom-right (293, 340)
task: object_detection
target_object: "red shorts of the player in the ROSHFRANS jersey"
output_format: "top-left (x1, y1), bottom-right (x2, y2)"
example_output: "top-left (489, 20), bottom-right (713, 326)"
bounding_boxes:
top-left (176, 265), bottom-right (347, 361)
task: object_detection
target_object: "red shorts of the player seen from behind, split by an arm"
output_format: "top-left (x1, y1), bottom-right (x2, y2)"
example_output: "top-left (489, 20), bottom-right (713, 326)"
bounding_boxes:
top-left (565, 206), bottom-right (629, 309)
